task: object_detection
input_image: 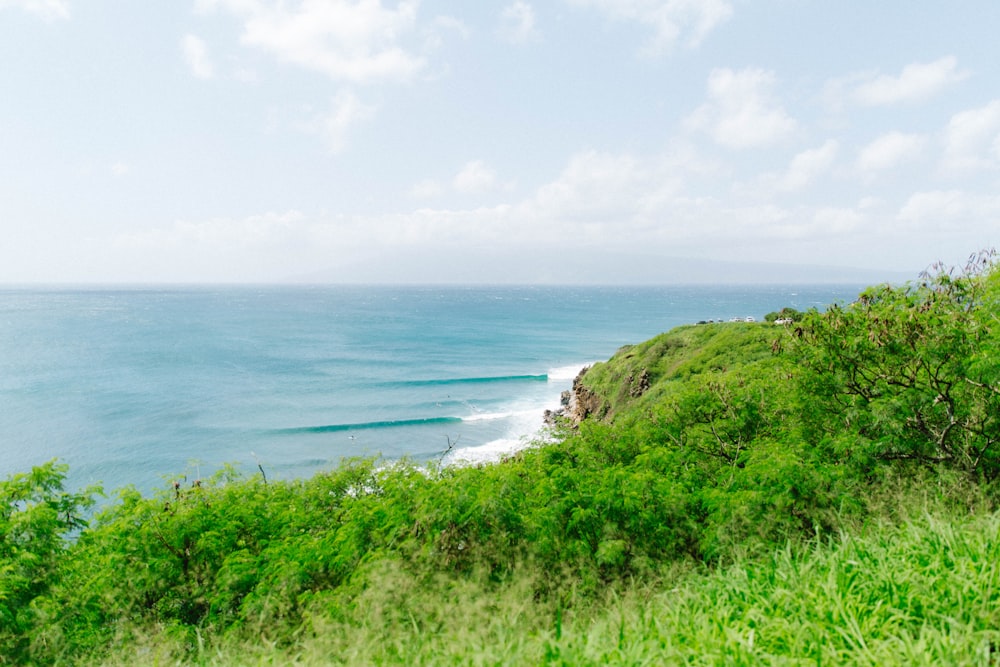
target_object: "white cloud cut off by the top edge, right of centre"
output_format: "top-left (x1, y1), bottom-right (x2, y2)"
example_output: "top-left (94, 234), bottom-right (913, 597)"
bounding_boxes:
top-left (569, 0), bottom-right (733, 55)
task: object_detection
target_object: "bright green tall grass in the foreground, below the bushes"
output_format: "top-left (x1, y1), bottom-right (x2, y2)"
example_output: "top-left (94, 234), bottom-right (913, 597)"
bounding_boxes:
top-left (92, 506), bottom-right (1000, 665)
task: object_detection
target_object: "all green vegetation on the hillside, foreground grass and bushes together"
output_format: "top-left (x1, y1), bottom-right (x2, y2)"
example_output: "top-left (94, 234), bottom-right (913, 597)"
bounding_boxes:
top-left (0, 250), bottom-right (1000, 664)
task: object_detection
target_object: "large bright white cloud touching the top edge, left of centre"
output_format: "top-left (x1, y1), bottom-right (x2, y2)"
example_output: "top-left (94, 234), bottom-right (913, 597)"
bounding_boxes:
top-left (197, 0), bottom-right (425, 83)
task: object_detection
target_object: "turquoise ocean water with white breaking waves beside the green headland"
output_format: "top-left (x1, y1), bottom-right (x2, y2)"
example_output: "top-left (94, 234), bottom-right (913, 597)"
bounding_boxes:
top-left (0, 285), bottom-right (861, 491)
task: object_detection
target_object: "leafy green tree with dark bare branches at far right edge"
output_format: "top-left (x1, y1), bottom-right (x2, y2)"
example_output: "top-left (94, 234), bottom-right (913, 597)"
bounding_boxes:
top-left (796, 251), bottom-right (1000, 480)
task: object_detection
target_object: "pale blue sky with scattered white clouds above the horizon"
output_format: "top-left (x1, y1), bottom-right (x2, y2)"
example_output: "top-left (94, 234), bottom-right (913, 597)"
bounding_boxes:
top-left (0, 0), bottom-right (1000, 284)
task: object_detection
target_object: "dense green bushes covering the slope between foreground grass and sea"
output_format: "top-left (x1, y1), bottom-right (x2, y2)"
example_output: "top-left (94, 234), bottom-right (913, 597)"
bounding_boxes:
top-left (0, 256), bottom-right (1000, 663)
